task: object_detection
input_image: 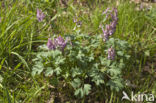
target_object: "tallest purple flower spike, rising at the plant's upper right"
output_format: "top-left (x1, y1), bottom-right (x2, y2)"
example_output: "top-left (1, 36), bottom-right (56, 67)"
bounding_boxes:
top-left (102, 8), bottom-right (118, 41)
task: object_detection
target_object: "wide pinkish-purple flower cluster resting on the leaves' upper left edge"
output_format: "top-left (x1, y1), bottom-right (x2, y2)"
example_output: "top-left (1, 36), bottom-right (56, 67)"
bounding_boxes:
top-left (47, 36), bottom-right (68, 51)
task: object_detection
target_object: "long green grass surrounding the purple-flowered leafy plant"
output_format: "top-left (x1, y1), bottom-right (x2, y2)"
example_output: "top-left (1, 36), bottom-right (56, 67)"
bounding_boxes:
top-left (0, 0), bottom-right (156, 103)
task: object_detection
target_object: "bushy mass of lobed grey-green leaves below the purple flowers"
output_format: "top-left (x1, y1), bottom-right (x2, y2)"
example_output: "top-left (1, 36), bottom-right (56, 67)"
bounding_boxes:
top-left (32, 34), bottom-right (130, 98)
